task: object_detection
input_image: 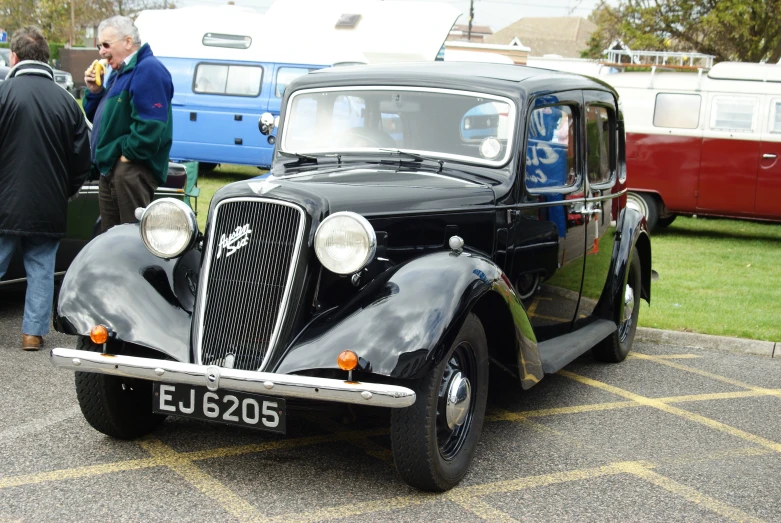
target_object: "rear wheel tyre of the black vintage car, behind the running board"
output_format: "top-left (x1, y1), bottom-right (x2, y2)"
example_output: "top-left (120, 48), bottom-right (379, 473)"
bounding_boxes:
top-left (592, 248), bottom-right (642, 363)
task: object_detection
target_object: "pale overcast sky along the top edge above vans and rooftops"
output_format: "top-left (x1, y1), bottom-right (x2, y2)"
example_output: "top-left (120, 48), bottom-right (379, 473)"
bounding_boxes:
top-left (176, 0), bottom-right (599, 31)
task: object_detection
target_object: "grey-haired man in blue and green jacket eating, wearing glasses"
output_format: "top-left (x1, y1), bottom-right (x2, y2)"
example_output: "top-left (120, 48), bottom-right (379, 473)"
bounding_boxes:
top-left (83, 16), bottom-right (174, 231)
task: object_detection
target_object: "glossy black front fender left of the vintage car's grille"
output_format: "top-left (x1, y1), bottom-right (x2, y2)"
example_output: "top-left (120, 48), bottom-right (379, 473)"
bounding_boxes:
top-left (54, 224), bottom-right (200, 362)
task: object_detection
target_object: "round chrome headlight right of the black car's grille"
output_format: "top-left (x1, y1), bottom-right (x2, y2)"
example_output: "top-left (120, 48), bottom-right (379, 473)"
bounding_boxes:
top-left (315, 212), bottom-right (377, 274)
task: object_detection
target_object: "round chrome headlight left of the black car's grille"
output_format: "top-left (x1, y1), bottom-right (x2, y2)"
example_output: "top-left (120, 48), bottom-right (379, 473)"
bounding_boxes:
top-left (141, 198), bottom-right (198, 259)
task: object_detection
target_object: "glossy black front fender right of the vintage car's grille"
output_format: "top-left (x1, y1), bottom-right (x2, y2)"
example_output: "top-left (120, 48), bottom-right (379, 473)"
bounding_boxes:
top-left (274, 252), bottom-right (539, 379)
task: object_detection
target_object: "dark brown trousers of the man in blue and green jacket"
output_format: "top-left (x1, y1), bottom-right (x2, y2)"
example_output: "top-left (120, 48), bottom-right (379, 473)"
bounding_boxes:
top-left (98, 160), bottom-right (159, 231)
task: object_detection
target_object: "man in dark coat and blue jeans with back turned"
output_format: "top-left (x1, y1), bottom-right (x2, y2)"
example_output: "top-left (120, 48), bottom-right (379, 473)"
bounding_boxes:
top-left (0, 27), bottom-right (90, 350)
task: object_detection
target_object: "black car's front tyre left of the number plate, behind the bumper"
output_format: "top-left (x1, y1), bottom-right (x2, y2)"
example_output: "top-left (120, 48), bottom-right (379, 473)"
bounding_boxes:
top-left (76, 336), bottom-right (166, 439)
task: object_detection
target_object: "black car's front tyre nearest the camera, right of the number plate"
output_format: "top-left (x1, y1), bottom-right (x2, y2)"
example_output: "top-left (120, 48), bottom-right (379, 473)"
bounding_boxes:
top-left (391, 314), bottom-right (488, 492)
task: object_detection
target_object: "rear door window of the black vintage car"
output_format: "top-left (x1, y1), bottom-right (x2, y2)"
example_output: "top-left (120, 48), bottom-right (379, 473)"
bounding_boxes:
top-left (586, 105), bottom-right (616, 184)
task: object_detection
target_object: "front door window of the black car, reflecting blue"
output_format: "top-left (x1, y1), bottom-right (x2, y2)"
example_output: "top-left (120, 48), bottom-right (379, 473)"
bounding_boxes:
top-left (526, 105), bottom-right (576, 190)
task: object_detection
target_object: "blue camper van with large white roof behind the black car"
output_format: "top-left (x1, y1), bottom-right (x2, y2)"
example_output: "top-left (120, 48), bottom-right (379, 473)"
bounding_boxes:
top-left (135, 0), bottom-right (461, 170)
